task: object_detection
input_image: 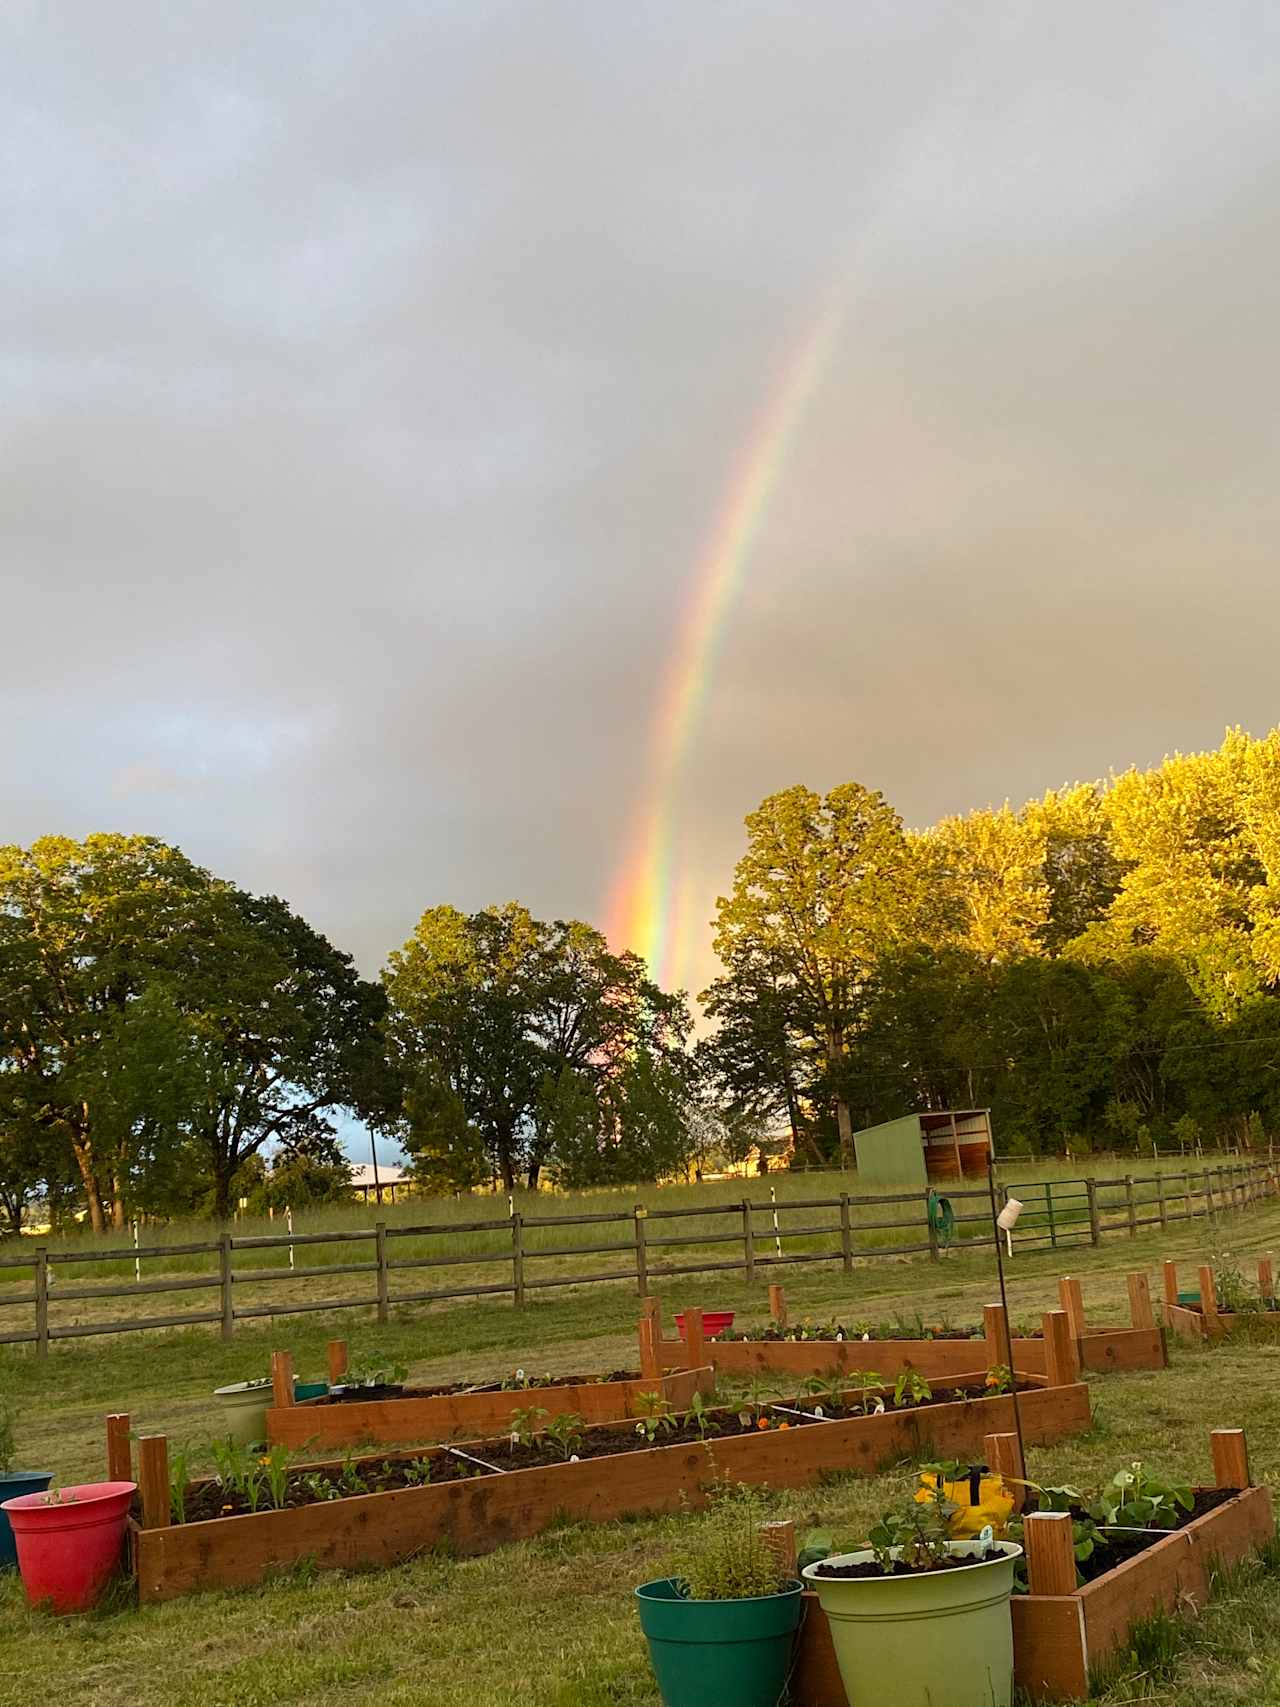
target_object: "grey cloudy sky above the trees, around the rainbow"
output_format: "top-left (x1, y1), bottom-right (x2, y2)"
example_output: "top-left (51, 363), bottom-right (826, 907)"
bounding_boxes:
top-left (0, 0), bottom-right (1280, 1010)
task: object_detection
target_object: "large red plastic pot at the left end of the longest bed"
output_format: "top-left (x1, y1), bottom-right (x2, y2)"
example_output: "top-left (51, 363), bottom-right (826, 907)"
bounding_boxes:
top-left (3, 1482), bottom-right (138, 1611)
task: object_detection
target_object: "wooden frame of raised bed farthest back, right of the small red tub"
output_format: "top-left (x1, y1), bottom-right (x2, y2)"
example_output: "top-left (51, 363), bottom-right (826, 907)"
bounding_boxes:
top-left (640, 1273), bottom-right (1169, 1383)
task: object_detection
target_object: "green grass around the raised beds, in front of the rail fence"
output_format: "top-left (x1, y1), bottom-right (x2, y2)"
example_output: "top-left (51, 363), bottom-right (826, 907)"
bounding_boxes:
top-left (0, 1183), bottom-right (1280, 1707)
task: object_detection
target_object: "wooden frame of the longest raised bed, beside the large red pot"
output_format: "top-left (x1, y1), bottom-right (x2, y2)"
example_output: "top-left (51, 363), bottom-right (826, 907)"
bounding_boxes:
top-left (108, 1384), bottom-right (1091, 1603)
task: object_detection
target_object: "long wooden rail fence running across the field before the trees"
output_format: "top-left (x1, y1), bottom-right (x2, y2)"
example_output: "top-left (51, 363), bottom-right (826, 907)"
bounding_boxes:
top-left (0, 1162), bottom-right (1280, 1357)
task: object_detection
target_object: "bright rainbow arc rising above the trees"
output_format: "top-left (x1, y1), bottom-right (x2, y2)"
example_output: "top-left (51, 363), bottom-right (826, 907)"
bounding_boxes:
top-left (606, 290), bottom-right (845, 988)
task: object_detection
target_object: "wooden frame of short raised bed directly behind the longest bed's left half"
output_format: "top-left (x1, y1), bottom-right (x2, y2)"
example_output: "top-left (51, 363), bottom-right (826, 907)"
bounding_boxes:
top-left (266, 1342), bottom-right (715, 1446)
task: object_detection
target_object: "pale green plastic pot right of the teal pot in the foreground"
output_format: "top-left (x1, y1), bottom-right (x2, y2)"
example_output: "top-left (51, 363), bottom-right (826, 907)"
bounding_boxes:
top-left (802, 1541), bottom-right (1022, 1707)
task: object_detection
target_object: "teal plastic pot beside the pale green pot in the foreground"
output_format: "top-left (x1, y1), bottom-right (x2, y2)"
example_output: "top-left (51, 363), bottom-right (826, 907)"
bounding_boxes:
top-left (635, 1577), bottom-right (802, 1707)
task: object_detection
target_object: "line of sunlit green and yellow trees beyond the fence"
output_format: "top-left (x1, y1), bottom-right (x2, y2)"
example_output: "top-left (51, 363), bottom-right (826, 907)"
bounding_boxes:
top-left (0, 731), bottom-right (1280, 1229)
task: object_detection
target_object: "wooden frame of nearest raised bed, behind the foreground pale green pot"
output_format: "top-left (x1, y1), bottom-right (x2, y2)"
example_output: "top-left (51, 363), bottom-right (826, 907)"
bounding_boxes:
top-left (792, 1429), bottom-right (1275, 1707)
